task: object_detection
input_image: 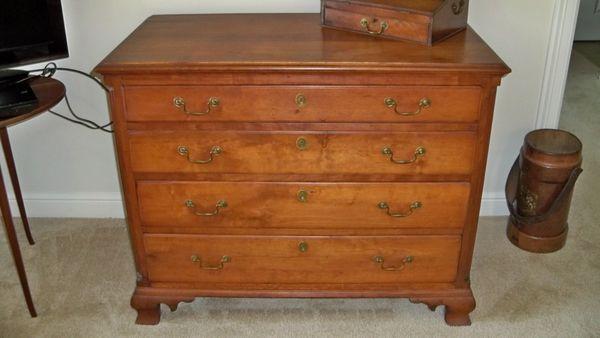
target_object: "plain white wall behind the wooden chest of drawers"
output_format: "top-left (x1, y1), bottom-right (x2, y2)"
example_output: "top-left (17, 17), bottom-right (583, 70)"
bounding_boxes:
top-left (4, 0), bottom-right (555, 217)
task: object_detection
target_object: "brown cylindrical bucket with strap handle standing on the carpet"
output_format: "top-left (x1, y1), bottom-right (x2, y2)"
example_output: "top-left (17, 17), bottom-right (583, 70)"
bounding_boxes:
top-left (506, 129), bottom-right (582, 253)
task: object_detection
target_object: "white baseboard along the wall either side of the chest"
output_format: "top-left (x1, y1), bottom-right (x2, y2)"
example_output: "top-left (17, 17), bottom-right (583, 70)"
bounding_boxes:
top-left (10, 193), bottom-right (508, 218)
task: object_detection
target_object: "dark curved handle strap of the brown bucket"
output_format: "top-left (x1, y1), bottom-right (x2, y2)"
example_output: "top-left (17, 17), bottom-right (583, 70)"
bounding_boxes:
top-left (504, 157), bottom-right (583, 224)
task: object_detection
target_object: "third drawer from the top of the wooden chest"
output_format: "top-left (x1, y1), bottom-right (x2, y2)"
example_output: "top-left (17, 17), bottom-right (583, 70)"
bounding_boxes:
top-left (138, 182), bottom-right (469, 229)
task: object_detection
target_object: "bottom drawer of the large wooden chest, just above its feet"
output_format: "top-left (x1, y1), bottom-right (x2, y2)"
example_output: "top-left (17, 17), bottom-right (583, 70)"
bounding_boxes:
top-left (144, 235), bottom-right (460, 284)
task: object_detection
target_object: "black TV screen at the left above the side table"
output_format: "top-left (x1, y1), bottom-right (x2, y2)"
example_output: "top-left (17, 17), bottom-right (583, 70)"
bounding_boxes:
top-left (0, 0), bottom-right (69, 69)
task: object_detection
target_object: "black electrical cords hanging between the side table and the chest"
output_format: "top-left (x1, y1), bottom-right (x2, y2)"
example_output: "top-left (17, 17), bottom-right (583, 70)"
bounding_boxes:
top-left (26, 62), bottom-right (114, 133)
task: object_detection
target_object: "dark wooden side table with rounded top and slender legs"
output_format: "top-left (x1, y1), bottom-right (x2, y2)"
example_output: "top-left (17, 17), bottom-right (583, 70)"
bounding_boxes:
top-left (0, 78), bottom-right (65, 317)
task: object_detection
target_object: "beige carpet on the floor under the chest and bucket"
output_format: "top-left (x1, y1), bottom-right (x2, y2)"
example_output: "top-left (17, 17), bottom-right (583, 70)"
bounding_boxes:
top-left (0, 46), bottom-right (600, 337)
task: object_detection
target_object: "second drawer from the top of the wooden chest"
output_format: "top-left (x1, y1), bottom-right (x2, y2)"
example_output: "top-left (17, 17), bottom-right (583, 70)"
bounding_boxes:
top-left (130, 131), bottom-right (476, 175)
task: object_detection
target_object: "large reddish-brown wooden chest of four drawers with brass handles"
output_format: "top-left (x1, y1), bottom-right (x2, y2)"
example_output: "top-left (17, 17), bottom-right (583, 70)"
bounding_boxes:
top-left (96, 14), bottom-right (509, 325)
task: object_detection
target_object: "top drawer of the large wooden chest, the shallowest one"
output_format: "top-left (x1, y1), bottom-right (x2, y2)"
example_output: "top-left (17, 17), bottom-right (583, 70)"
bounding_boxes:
top-left (125, 86), bottom-right (481, 123)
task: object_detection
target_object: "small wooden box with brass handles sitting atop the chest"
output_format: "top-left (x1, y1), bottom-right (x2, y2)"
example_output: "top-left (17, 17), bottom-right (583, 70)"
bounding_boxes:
top-left (321, 0), bottom-right (469, 46)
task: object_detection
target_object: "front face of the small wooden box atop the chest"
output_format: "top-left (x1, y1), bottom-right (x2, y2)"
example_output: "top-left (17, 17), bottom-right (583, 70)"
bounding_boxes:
top-left (323, 1), bottom-right (431, 44)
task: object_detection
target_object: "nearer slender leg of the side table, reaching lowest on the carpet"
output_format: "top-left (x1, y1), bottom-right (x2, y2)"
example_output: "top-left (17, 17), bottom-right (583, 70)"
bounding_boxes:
top-left (0, 163), bottom-right (37, 317)
